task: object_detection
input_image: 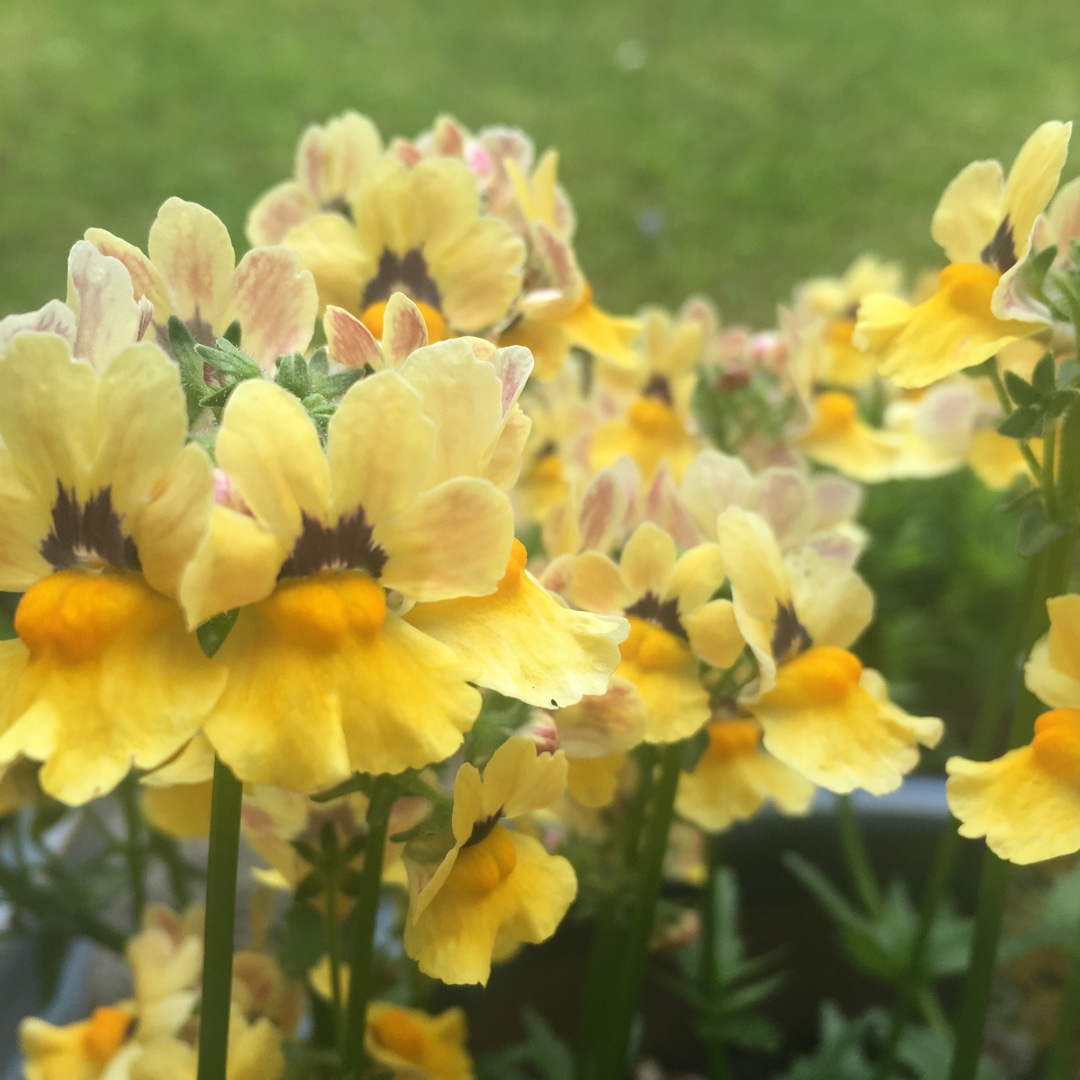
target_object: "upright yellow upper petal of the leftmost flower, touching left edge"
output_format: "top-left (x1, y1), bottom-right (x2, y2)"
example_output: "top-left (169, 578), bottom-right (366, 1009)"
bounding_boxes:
top-left (0, 333), bottom-right (99, 498)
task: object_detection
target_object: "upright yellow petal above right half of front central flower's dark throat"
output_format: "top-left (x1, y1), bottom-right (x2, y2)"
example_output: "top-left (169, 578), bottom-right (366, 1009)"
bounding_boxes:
top-left (326, 372), bottom-right (434, 524)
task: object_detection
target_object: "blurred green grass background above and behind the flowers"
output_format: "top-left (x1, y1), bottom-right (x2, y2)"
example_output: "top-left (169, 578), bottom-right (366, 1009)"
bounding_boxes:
top-left (0, 0), bottom-right (1080, 742)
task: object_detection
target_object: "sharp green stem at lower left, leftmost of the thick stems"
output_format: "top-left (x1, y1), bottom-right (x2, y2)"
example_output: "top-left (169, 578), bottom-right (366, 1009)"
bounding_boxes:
top-left (198, 758), bottom-right (244, 1080)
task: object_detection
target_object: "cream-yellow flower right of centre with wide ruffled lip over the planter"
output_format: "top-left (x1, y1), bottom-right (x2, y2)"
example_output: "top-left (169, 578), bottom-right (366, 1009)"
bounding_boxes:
top-left (717, 508), bottom-right (942, 795)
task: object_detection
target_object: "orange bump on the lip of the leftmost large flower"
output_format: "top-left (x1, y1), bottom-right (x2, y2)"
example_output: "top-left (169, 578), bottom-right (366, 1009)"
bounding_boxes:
top-left (15, 570), bottom-right (176, 662)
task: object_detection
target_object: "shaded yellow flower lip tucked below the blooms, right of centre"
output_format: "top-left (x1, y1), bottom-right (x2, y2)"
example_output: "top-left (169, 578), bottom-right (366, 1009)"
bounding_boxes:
top-left (675, 718), bottom-right (814, 833)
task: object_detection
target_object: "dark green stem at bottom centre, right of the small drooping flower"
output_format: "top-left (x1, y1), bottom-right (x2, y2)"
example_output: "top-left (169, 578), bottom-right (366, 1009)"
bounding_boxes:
top-left (598, 742), bottom-right (683, 1080)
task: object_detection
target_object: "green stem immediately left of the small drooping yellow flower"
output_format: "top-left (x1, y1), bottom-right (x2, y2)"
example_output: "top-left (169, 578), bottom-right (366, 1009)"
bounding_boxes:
top-left (342, 777), bottom-right (395, 1080)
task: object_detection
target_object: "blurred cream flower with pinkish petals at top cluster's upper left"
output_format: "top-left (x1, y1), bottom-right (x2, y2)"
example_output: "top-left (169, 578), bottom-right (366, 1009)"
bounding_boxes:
top-left (245, 111), bottom-right (382, 247)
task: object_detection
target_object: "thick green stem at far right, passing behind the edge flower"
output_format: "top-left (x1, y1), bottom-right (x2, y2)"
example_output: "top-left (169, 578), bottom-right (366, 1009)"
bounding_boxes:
top-left (949, 532), bottom-right (1074, 1080)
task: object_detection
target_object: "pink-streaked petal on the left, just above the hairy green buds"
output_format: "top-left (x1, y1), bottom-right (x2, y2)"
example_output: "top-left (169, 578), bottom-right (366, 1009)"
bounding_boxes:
top-left (221, 247), bottom-right (319, 372)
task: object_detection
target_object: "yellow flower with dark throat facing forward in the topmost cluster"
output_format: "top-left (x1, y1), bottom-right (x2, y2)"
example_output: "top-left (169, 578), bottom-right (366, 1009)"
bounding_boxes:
top-left (285, 159), bottom-right (525, 341)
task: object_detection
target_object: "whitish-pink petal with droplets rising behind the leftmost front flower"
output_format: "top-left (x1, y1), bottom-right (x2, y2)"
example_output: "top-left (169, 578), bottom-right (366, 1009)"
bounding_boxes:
top-left (68, 240), bottom-right (140, 370)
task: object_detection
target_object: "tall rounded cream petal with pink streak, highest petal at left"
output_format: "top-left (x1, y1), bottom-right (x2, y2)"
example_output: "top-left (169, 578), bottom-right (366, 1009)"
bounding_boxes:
top-left (147, 198), bottom-right (237, 324)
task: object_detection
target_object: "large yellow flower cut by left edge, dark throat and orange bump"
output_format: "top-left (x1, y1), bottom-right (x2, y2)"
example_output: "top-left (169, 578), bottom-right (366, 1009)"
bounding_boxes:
top-left (0, 333), bottom-right (226, 804)
